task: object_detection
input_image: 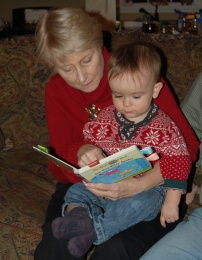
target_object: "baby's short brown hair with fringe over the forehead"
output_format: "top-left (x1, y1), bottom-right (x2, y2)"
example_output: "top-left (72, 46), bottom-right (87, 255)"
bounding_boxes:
top-left (108, 39), bottom-right (162, 83)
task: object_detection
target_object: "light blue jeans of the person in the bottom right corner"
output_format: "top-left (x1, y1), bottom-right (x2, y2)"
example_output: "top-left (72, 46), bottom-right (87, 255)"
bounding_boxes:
top-left (140, 207), bottom-right (202, 260)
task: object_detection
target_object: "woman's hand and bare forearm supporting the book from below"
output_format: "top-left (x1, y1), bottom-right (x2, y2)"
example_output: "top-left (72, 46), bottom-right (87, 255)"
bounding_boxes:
top-left (83, 163), bottom-right (163, 200)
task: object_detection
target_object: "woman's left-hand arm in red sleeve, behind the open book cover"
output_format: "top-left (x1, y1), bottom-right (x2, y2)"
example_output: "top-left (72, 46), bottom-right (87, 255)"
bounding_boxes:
top-left (45, 75), bottom-right (87, 183)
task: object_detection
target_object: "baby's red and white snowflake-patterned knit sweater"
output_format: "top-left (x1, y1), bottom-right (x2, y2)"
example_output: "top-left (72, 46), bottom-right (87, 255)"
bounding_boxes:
top-left (84, 105), bottom-right (192, 193)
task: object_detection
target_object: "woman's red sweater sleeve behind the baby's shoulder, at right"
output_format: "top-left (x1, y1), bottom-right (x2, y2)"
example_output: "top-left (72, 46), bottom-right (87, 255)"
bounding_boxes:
top-left (154, 78), bottom-right (199, 163)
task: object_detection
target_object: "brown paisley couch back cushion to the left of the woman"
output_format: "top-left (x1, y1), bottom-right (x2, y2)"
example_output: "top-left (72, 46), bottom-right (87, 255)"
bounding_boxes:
top-left (0, 35), bottom-right (52, 149)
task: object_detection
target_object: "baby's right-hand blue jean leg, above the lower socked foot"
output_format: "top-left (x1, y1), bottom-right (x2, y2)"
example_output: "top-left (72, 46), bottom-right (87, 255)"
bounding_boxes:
top-left (94, 187), bottom-right (165, 244)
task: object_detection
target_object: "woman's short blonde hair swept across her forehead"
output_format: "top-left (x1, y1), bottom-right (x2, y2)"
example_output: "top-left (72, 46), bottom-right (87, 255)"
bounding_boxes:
top-left (35, 8), bottom-right (103, 66)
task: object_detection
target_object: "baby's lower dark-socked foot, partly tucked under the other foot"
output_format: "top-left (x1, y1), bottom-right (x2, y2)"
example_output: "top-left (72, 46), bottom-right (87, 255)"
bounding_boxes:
top-left (67, 230), bottom-right (97, 257)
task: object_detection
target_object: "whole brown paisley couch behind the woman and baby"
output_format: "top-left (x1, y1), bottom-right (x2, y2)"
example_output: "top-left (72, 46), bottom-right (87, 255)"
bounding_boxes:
top-left (0, 31), bottom-right (202, 260)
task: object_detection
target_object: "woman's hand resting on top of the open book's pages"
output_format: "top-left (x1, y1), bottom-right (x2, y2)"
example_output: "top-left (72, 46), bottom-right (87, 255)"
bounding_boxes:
top-left (77, 144), bottom-right (106, 167)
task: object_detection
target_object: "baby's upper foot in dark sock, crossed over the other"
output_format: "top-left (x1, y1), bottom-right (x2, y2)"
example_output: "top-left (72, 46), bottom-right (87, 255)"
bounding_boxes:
top-left (52, 207), bottom-right (94, 240)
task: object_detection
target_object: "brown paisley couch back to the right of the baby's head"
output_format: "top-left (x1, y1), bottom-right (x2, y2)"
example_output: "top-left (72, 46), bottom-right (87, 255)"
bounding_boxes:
top-left (113, 31), bottom-right (202, 102)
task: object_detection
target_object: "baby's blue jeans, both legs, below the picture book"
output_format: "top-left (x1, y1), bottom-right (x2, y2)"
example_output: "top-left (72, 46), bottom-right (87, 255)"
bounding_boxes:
top-left (62, 183), bottom-right (165, 245)
